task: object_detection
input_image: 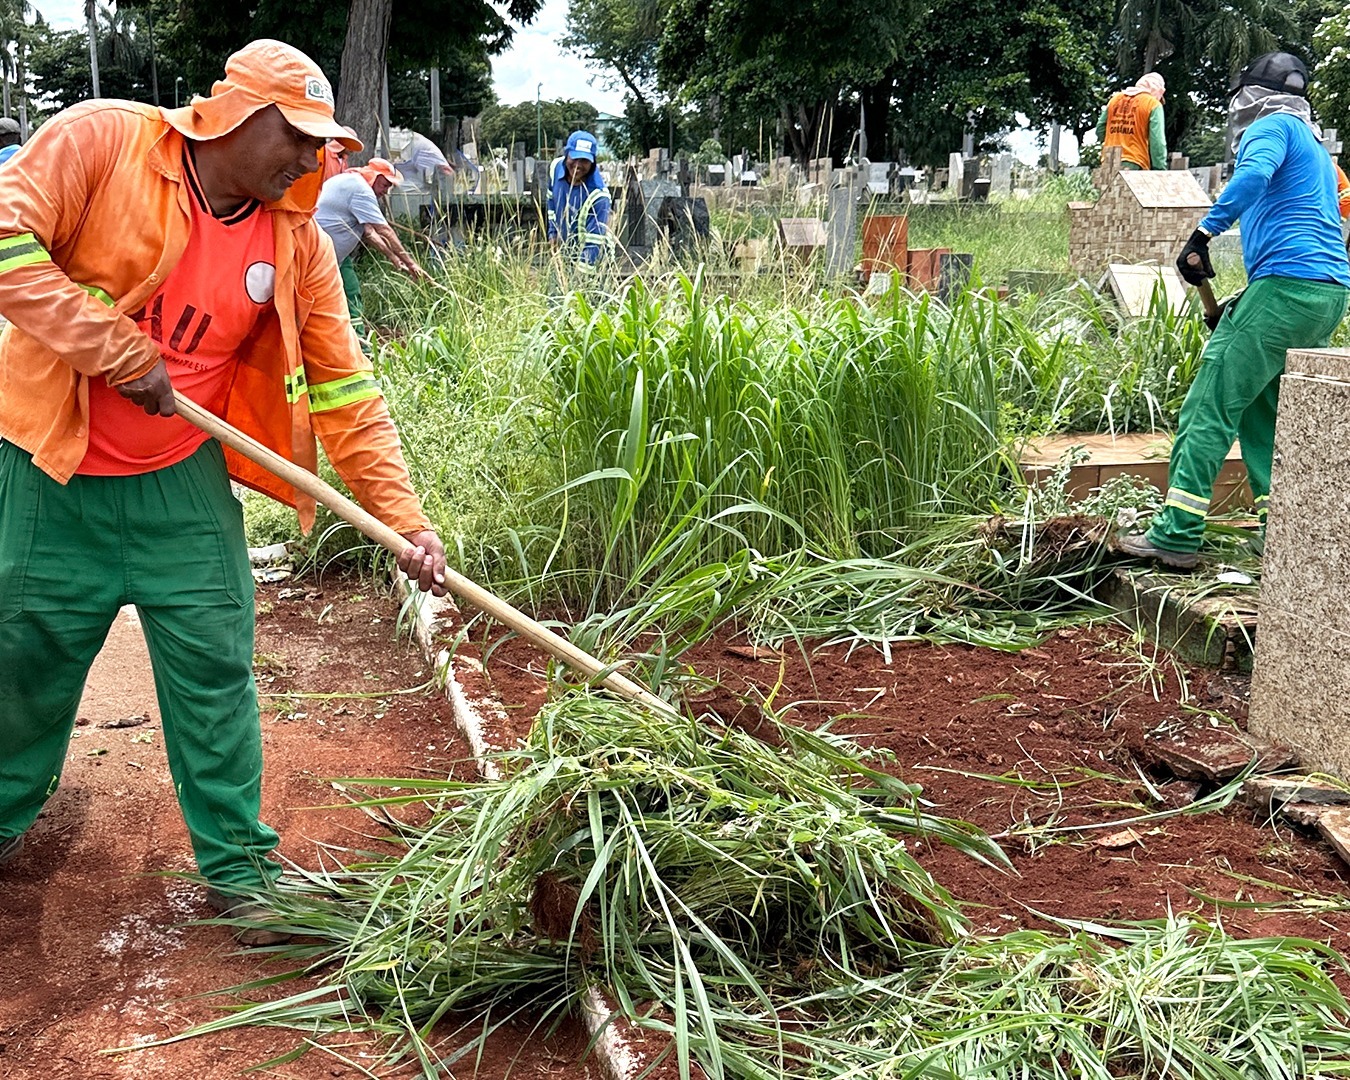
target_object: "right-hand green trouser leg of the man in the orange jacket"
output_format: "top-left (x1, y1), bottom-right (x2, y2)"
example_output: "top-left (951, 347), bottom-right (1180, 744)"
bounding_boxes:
top-left (127, 441), bottom-right (281, 892)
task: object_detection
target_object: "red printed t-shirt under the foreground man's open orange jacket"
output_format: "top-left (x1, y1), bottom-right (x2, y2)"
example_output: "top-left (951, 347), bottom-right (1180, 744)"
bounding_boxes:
top-left (76, 151), bottom-right (277, 477)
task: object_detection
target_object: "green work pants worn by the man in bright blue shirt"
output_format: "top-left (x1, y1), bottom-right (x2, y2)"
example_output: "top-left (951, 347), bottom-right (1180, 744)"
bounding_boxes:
top-left (1149, 278), bottom-right (1350, 551)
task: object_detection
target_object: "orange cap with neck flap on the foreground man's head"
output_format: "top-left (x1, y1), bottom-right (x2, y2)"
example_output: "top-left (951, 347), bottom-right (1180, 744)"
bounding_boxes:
top-left (165, 38), bottom-right (362, 151)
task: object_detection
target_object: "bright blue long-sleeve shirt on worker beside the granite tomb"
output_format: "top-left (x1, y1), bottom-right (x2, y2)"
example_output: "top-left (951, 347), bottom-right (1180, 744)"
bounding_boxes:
top-left (1200, 113), bottom-right (1350, 288)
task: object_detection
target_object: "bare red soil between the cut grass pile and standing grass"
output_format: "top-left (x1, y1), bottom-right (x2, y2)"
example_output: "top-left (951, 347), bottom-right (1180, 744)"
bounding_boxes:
top-left (472, 629), bottom-right (1350, 961)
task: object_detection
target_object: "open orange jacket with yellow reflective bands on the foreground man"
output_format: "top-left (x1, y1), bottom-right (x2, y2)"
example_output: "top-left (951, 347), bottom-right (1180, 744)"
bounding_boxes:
top-left (0, 100), bottom-right (429, 533)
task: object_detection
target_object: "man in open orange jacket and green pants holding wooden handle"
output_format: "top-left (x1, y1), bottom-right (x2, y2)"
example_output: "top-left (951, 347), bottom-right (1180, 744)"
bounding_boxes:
top-left (0, 41), bottom-right (446, 944)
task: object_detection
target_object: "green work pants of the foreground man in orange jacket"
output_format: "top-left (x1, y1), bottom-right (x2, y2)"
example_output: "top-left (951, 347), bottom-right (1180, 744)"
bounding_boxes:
top-left (0, 440), bottom-right (281, 892)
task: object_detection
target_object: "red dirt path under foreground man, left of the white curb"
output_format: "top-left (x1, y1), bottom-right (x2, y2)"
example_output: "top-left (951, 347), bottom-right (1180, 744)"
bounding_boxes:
top-left (0, 578), bottom-right (599, 1080)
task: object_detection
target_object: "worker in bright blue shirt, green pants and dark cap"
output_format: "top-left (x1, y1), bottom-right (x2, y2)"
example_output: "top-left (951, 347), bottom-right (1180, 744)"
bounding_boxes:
top-left (1118, 53), bottom-right (1350, 570)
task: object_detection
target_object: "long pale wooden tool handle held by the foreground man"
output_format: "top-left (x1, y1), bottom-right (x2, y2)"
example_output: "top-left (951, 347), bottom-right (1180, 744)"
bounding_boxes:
top-left (173, 390), bottom-right (675, 714)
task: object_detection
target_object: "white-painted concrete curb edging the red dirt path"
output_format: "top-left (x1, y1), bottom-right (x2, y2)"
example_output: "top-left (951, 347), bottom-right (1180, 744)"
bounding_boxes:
top-left (393, 570), bottom-right (648, 1080)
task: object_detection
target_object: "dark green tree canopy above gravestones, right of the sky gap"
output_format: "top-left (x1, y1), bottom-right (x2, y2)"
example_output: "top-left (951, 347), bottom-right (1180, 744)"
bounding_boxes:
top-left (566, 0), bottom-right (1342, 163)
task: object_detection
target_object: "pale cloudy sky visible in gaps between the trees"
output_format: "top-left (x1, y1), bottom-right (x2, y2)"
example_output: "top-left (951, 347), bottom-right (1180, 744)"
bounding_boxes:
top-left (32, 0), bottom-right (624, 112)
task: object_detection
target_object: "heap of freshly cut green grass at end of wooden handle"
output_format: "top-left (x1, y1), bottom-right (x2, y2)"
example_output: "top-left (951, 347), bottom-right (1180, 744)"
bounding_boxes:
top-left (196, 694), bottom-right (1350, 1080)
